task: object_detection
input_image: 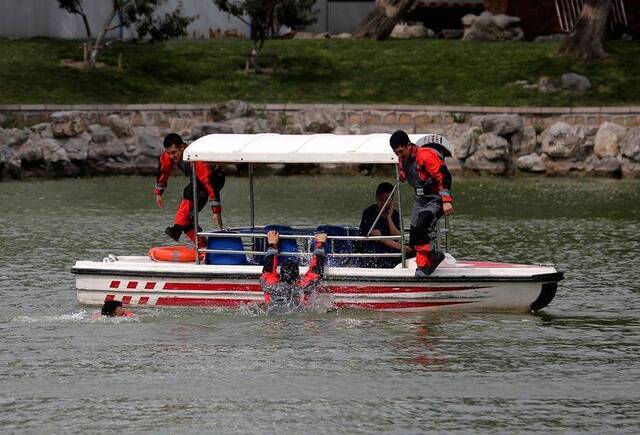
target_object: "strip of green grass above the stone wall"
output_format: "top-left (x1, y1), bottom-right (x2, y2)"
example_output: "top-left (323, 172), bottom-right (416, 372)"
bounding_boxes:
top-left (0, 39), bottom-right (640, 106)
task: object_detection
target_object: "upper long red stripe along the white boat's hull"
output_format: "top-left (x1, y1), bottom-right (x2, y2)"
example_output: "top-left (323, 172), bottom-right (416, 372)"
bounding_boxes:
top-left (163, 282), bottom-right (486, 294)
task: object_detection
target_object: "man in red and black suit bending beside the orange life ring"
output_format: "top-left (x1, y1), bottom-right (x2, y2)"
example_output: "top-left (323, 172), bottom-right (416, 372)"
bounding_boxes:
top-left (154, 133), bottom-right (225, 243)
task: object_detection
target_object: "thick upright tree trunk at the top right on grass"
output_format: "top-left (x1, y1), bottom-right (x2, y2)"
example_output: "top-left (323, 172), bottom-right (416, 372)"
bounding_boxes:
top-left (560, 0), bottom-right (611, 61)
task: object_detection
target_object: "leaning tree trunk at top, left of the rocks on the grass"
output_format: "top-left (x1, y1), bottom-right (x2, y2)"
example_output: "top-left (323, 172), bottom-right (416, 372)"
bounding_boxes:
top-left (353, 0), bottom-right (418, 41)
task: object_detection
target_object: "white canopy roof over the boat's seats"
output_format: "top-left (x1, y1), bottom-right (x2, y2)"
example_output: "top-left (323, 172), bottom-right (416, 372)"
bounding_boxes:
top-left (184, 133), bottom-right (438, 164)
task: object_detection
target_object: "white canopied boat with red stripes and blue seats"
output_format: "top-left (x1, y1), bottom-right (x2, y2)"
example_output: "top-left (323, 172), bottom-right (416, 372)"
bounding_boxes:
top-left (72, 134), bottom-right (563, 312)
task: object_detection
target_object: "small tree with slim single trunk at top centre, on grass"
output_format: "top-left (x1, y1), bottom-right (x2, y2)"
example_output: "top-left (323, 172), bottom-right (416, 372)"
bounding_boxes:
top-left (213, 0), bottom-right (316, 71)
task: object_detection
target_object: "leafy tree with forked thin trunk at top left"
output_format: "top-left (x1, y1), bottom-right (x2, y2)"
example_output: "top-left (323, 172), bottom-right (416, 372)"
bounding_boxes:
top-left (58, 0), bottom-right (195, 68)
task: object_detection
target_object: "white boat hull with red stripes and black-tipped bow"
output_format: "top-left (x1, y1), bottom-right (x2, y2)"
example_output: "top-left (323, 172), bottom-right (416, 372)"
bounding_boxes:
top-left (73, 255), bottom-right (562, 312)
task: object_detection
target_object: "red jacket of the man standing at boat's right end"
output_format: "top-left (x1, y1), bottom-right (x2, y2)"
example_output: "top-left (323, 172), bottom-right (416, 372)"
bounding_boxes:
top-left (398, 145), bottom-right (453, 202)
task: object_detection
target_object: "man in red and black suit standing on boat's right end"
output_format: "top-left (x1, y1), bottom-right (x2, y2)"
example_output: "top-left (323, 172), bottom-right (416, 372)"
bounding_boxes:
top-left (389, 130), bottom-right (453, 278)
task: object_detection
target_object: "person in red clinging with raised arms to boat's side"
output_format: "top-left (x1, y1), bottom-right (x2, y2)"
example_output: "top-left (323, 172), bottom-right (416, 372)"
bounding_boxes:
top-left (260, 231), bottom-right (327, 312)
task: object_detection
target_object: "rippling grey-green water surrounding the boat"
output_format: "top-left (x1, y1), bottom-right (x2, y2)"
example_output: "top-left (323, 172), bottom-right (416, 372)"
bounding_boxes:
top-left (0, 177), bottom-right (640, 434)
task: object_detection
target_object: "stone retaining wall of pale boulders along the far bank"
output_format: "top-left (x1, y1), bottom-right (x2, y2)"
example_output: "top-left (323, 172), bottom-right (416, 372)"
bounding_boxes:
top-left (0, 101), bottom-right (640, 179)
